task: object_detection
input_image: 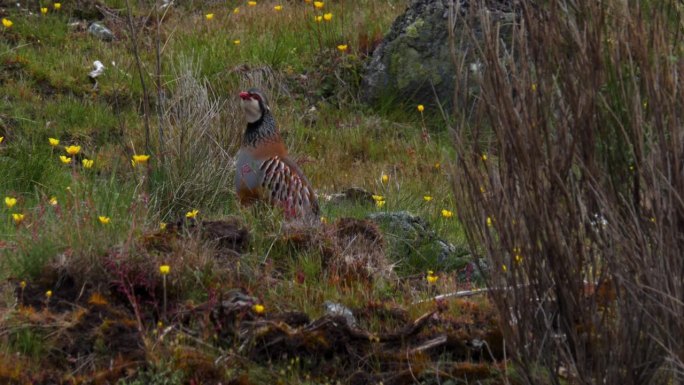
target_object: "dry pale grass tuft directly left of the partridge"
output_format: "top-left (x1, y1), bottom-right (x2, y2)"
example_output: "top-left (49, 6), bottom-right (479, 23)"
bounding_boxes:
top-left (151, 59), bottom-right (241, 216)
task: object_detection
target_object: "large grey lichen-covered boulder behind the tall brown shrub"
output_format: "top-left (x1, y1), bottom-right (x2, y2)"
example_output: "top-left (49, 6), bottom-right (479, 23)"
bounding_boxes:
top-left (362, 0), bottom-right (514, 109)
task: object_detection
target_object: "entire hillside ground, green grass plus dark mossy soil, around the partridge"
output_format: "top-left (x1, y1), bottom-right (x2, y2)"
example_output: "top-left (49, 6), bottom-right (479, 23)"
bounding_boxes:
top-left (0, 0), bottom-right (500, 384)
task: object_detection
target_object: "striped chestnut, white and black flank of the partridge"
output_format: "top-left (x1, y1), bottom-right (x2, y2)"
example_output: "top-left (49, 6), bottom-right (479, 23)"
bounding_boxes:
top-left (260, 156), bottom-right (319, 216)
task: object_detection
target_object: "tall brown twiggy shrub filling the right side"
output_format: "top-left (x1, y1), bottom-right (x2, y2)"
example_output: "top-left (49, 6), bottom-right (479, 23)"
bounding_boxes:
top-left (452, 0), bottom-right (684, 384)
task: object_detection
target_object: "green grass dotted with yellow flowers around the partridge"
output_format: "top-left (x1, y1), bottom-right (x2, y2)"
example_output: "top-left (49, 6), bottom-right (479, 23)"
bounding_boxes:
top-left (0, 0), bottom-right (488, 384)
